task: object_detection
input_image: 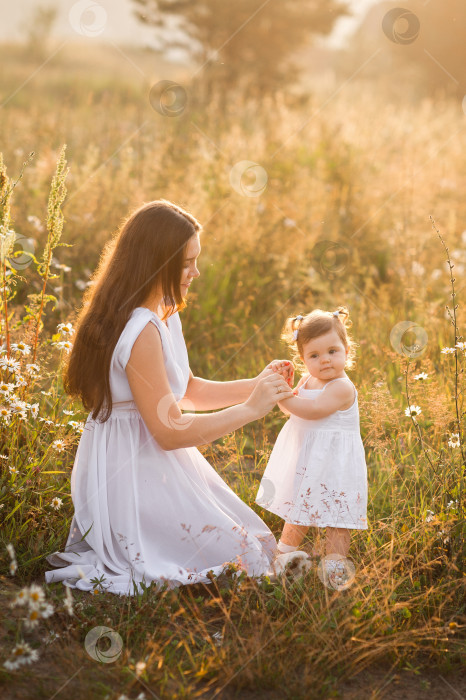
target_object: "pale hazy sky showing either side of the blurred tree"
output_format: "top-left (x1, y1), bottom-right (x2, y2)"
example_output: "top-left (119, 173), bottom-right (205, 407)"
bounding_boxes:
top-left (0, 0), bottom-right (377, 52)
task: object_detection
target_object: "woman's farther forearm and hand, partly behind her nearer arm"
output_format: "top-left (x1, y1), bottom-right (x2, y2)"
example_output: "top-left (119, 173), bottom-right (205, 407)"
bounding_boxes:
top-left (178, 360), bottom-right (292, 411)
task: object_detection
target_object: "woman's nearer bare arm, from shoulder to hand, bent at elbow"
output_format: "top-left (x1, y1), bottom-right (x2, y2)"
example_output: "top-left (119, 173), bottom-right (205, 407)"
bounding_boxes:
top-left (125, 322), bottom-right (292, 450)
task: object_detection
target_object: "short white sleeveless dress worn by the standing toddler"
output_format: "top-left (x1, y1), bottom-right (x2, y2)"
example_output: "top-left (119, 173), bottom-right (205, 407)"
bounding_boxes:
top-left (256, 377), bottom-right (367, 530)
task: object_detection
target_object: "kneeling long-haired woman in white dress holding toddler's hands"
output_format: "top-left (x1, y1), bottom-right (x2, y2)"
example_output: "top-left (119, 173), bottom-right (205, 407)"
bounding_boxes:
top-left (45, 200), bottom-right (292, 595)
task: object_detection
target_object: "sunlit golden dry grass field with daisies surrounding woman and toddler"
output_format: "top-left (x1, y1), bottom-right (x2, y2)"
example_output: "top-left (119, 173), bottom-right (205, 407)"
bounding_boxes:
top-left (0, 42), bottom-right (466, 700)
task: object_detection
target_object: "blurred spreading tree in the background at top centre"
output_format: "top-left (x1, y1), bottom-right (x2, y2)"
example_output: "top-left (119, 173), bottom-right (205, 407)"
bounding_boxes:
top-left (133, 0), bottom-right (349, 101)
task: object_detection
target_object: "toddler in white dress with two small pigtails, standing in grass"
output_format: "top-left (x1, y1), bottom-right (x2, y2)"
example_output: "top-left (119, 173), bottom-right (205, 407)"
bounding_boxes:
top-left (256, 306), bottom-right (367, 580)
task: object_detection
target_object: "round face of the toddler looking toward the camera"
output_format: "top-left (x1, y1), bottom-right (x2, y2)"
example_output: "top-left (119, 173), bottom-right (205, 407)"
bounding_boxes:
top-left (302, 331), bottom-right (348, 381)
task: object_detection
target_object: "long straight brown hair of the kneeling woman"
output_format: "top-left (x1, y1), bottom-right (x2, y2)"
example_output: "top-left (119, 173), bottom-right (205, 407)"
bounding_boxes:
top-left (63, 199), bottom-right (202, 422)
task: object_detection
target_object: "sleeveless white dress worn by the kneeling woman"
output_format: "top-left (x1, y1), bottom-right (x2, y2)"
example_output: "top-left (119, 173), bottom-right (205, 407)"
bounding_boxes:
top-left (45, 307), bottom-right (276, 595)
